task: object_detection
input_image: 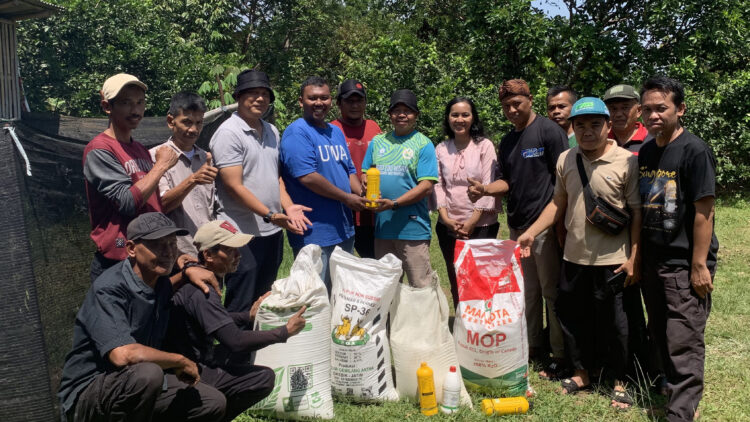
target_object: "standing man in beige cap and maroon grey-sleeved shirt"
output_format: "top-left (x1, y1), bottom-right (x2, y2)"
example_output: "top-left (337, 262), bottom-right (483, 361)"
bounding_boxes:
top-left (83, 73), bottom-right (177, 282)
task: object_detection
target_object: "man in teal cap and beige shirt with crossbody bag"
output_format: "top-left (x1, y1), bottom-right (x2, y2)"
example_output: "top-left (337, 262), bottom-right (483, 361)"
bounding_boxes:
top-left (518, 97), bottom-right (641, 408)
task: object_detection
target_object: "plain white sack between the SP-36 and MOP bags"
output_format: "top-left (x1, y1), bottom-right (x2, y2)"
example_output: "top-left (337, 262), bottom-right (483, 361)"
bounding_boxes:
top-left (390, 273), bottom-right (472, 407)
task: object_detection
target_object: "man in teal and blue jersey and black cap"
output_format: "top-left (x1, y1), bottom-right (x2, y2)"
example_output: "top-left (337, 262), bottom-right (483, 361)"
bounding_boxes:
top-left (362, 89), bottom-right (438, 287)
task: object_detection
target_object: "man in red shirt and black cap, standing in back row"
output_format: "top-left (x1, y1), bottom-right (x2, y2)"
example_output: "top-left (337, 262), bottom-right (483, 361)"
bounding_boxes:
top-left (331, 79), bottom-right (381, 258)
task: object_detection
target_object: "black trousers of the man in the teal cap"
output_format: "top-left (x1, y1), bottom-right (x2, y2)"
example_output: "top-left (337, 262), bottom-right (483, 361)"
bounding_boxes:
top-left (555, 260), bottom-right (628, 380)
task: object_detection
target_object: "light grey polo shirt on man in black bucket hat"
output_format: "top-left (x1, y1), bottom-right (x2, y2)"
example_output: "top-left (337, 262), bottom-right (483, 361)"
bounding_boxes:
top-left (209, 112), bottom-right (282, 236)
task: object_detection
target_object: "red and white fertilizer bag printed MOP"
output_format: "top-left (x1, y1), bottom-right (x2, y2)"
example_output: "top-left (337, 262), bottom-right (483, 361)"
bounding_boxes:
top-left (453, 239), bottom-right (529, 396)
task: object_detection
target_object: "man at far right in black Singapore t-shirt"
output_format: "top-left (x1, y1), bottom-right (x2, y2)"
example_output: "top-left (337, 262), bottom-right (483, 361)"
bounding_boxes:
top-left (638, 77), bottom-right (719, 421)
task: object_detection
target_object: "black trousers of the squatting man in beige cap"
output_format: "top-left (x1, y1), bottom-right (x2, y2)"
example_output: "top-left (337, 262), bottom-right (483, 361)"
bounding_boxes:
top-left (200, 365), bottom-right (276, 422)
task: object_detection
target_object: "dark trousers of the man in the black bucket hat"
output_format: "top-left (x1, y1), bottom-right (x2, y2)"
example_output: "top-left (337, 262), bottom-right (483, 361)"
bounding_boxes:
top-left (224, 231), bottom-right (284, 312)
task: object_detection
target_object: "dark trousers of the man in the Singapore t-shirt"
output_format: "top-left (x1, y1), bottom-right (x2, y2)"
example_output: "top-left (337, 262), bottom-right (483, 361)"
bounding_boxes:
top-left (641, 253), bottom-right (715, 421)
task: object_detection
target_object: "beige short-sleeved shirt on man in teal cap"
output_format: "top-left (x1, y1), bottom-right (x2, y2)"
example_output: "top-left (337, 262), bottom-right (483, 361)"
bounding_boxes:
top-left (555, 139), bottom-right (641, 265)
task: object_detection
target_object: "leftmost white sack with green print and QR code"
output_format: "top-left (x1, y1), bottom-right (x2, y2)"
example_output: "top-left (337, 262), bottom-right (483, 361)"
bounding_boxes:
top-left (250, 245), bottom-right (334, 419)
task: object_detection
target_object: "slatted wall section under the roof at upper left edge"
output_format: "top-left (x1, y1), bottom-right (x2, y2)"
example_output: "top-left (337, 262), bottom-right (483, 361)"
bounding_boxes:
top-left (0, 19), bottom-right (21, 120)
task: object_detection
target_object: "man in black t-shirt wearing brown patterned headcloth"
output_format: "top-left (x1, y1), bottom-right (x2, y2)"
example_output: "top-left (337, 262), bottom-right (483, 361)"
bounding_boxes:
top-left (468, 79), bottom-right (568, 378)
